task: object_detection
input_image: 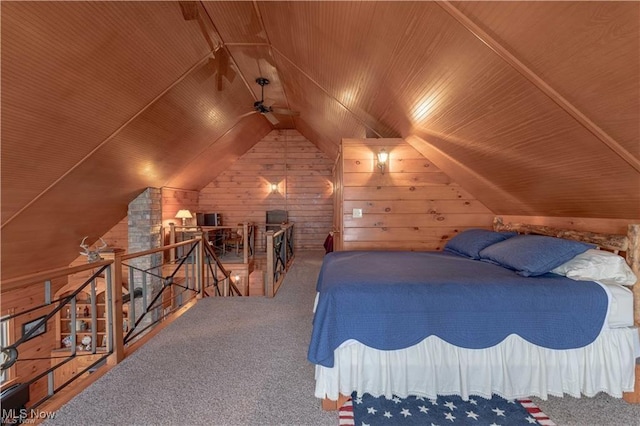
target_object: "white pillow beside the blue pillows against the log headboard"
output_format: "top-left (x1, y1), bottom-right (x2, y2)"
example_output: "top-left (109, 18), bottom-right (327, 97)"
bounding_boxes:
top-left (551, 249), bottom-right (637, 285)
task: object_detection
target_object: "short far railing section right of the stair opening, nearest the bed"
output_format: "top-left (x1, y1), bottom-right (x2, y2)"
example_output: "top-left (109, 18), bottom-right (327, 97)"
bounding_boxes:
top-left (265, 222), bottom-right (295, 297)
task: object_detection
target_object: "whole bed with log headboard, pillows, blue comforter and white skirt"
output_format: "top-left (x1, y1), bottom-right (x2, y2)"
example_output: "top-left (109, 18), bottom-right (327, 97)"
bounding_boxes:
top-left (308, 218), bottom-right (640, 409)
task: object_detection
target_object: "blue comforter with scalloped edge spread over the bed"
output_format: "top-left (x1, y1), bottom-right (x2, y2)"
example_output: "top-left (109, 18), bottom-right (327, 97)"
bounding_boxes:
top-left (308, 251), bottom-right (608, 367)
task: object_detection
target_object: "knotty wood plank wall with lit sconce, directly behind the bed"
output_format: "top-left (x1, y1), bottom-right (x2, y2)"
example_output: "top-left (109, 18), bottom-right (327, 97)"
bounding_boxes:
top-left (342, 139), bottom-right (493, 250)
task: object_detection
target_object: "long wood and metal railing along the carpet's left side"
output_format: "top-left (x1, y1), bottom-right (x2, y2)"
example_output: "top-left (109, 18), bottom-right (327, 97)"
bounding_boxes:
top-left (0, 233), bottom-right (232, 422)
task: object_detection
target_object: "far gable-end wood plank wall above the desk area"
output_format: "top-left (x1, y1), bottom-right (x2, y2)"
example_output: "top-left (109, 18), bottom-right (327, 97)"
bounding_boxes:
top-left (199, 130), bottom-right (333, 250)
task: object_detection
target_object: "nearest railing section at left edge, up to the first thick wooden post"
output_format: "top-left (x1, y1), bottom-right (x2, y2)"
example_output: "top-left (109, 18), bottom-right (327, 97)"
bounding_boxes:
top-left (0, 259), bottom-right (115, 416)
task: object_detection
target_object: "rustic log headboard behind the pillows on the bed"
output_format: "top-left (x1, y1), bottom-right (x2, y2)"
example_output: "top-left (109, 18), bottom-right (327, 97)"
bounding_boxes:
top-left (493, 217), bottom-right (640, 326)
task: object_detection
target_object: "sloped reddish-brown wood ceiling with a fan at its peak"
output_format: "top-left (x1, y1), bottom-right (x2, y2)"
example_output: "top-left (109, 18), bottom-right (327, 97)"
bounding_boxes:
top-left (0, 1), bottom-right (640, 278)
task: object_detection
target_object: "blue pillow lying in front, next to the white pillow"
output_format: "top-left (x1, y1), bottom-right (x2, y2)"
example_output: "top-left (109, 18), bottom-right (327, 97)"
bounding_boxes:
top-left (480, 235), bottom-right (595, 277)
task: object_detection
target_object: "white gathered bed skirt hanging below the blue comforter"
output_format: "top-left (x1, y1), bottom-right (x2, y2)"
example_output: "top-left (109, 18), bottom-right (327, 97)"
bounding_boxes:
top-left (315, 327), bottom-right (640, 400)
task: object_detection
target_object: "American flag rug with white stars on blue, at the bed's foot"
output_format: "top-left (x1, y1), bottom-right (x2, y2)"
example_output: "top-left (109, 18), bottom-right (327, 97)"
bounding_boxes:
top-left (339, 393), bottom-right (555, 426)
